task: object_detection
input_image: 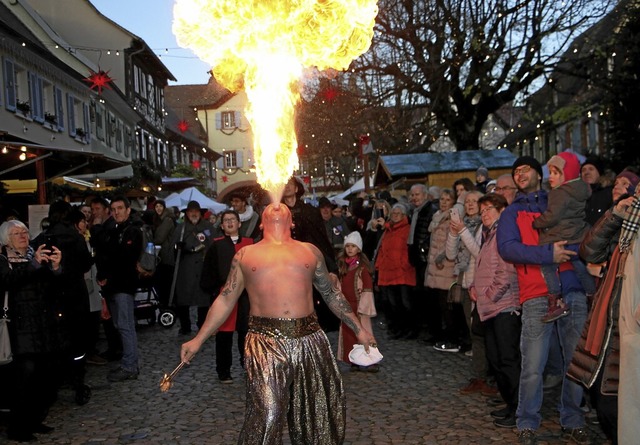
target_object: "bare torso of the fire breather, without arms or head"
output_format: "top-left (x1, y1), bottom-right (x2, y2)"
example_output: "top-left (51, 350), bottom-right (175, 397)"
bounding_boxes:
top-left (239, 240), bottom-right (318, 318)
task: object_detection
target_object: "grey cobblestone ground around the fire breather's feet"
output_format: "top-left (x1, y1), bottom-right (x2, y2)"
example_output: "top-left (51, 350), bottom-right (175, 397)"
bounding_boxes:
top-left (0, 318), bottom-right (608, 445)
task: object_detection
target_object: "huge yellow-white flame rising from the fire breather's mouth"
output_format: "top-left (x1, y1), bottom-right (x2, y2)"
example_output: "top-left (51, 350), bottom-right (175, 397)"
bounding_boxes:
top-left (173, 0), bottom-right (378, 196)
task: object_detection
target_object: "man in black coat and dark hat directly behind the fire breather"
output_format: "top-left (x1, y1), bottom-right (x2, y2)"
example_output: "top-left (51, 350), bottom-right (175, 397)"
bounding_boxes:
top-left (282, 176), bottom-right (340, 332)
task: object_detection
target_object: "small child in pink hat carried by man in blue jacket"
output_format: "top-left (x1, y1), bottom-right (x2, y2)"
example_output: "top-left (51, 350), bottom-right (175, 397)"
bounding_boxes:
top-left (533, 151), bottom-right (595, 323)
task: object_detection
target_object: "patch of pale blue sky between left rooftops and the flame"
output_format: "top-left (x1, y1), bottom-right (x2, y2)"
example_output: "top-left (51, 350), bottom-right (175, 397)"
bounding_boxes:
top-left (90, 0), bottom-right (210, 85)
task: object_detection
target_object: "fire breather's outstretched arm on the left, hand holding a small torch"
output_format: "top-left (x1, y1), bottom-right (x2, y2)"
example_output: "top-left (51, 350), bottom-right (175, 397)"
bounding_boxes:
top-left (180, 248), bottom-right (245, 363)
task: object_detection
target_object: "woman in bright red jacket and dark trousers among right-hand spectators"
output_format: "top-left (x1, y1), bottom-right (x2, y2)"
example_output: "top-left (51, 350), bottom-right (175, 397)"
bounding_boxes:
top-left (375, 203), bottom-right (418, 338)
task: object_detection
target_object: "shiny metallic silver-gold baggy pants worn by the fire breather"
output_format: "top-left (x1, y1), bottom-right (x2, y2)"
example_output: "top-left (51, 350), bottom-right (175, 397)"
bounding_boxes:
top-left (238, 314), bottom-right (346, 445)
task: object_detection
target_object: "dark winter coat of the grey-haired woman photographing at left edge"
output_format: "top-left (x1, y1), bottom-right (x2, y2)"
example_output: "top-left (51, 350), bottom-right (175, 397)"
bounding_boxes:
top-left (0, 247), bottom-right (62, 356)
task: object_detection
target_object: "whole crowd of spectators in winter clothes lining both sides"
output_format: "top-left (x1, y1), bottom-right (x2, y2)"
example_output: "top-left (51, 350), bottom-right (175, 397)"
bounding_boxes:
top-left (0, 152), bottom-right (640, 444)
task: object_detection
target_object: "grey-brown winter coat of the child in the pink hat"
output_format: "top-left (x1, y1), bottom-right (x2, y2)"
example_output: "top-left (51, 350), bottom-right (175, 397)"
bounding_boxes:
top-left (533, 179), bottom-right (591, 244)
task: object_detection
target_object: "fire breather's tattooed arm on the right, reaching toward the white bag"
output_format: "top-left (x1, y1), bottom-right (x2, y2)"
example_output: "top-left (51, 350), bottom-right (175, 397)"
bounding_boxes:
top-left (309, 244), bottom-right (375, 352)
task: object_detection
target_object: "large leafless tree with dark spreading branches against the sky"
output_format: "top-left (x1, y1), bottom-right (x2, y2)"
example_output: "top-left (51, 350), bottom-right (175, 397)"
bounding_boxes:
top-left (350, 0), bottom-right (615, 150)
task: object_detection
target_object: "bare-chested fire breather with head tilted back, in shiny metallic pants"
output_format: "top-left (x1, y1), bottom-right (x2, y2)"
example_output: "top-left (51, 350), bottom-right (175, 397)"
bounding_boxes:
top-left (181, 203), bottom-right (374, 445)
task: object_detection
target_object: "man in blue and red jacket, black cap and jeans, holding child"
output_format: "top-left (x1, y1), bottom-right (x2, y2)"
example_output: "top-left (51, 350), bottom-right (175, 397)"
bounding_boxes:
top-left (497, 156), bottom-right (590, 445)
